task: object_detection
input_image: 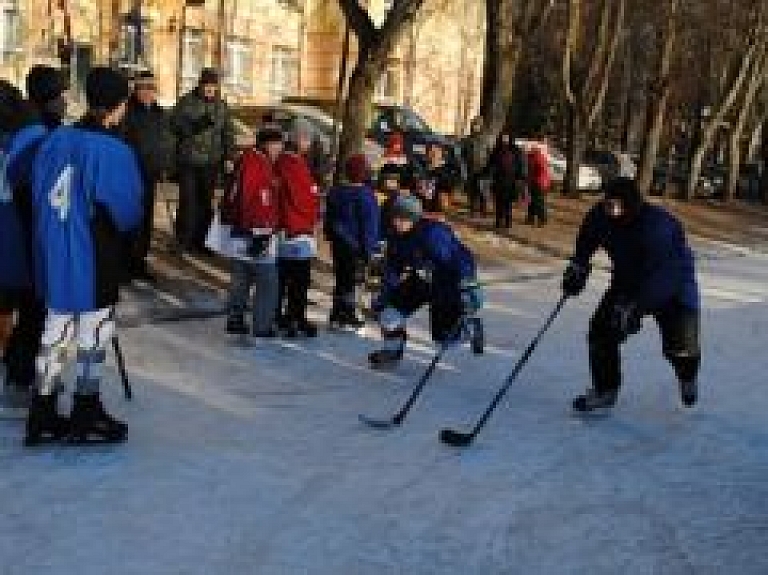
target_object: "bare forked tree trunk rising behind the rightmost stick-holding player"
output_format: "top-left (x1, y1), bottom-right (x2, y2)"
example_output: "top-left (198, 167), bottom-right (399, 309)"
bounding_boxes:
top-left (563, 0), bottom-right (626, 194)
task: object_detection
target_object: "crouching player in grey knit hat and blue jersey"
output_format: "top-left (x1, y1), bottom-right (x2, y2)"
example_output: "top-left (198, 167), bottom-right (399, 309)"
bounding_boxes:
top-left (368, 196), bottom-right (483, 367)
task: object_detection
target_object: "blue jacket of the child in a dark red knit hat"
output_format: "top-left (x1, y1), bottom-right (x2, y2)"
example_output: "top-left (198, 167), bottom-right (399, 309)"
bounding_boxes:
top-left (325, 185), bottom-right (381, 258)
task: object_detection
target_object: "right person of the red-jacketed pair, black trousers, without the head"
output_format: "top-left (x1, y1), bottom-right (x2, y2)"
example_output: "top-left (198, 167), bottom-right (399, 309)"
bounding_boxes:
top-left (275, 152), bottom-right (318, 338)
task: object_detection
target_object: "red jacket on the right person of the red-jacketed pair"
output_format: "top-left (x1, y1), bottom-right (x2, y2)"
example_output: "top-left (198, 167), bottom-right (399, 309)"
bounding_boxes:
top-left (275, 152), bottom-right (318, 238)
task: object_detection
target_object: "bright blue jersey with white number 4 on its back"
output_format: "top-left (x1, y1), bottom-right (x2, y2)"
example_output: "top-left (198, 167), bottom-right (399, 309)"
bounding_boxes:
top-left (32, 120), bottom-right (142, 313)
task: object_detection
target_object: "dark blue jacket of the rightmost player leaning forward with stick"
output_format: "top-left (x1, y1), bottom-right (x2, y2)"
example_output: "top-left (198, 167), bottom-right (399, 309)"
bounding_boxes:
top-left (573, 203), bottom-right (700, 313)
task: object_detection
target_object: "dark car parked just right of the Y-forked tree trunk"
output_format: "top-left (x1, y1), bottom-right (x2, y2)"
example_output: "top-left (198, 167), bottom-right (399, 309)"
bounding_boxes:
top-left (368, 104), bottom-right (466, 176)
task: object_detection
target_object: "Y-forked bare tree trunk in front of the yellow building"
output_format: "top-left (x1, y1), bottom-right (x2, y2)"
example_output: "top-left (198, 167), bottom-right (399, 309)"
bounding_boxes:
top-left (339, 0), bottom-right (424, 163)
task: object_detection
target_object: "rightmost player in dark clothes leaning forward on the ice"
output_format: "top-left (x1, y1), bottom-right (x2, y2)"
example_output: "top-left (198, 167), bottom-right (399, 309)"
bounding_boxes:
top-left (563, 179), bottom-right (701, 412)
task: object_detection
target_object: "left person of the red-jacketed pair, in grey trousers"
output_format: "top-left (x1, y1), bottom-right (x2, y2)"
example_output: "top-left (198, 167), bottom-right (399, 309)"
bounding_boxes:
top-left (221, 127), bottom-right (283, 337)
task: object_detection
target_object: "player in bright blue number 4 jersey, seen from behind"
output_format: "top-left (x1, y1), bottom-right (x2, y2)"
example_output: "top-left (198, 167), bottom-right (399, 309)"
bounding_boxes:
top-left (26, 67), bottom-right (142, 446)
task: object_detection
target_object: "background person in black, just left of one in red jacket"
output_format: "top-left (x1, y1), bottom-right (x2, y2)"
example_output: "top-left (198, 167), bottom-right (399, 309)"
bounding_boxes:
top-left (489, 133), bottom-right (528, 230)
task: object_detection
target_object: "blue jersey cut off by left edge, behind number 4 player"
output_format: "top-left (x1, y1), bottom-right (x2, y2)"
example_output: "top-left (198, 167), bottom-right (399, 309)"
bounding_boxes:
top-left (0, 124), bottom-right (47, 289)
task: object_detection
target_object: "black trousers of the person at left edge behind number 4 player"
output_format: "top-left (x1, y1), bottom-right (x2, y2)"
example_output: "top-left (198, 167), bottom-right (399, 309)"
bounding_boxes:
top-left (5, 288), bottom-right (46, 386)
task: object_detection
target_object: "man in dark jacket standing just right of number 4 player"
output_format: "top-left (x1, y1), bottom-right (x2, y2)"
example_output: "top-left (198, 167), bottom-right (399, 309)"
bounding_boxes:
top-left (123, 71), bottom-right (176, 282)
